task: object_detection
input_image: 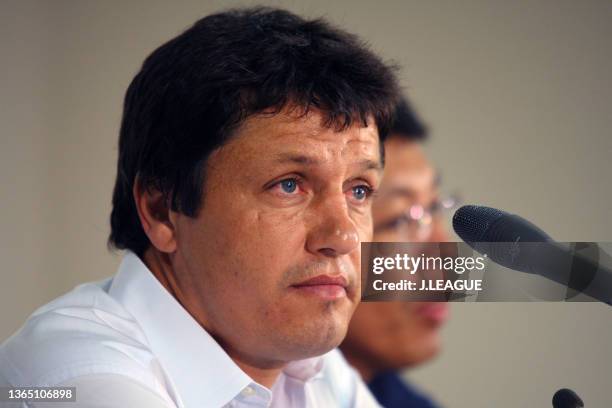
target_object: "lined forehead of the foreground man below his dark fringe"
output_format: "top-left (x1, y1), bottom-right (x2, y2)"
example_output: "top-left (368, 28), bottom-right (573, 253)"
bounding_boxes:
top-left (228, 110), bottom-right (380, 162)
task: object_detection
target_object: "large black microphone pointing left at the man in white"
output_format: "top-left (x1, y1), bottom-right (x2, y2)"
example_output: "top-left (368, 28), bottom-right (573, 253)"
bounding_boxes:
top-left (453, 205), bottom-right (612, 305)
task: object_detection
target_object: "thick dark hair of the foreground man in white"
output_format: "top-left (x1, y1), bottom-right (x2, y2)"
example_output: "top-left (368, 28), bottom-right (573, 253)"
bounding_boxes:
top-left (109, 8), bottom-right (399, 255)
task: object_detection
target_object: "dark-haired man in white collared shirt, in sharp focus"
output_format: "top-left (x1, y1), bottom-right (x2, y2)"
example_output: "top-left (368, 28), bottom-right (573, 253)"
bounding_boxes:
top-left (0, 9), bottom-right (398, 408)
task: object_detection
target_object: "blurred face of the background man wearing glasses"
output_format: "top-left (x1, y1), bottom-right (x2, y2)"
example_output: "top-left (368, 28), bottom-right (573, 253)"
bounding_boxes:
top-left (345, 137), bottom-right (448, 369)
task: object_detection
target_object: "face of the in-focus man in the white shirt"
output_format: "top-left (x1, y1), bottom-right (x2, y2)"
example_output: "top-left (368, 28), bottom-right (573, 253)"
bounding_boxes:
top-left (172, 108), bottom-right (381, 366)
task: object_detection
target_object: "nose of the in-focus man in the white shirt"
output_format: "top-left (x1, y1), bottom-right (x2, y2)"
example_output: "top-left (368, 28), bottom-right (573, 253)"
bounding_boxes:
top-left (306, 194), bottom-right (359, 258)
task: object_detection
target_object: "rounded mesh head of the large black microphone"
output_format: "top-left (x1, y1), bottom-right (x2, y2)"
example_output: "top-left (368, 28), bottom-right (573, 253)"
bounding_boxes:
top-left (453, 205), bottom-right (509, 243)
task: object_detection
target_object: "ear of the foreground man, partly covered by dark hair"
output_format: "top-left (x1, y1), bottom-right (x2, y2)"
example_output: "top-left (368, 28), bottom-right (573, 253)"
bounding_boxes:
top-left (132, 178), bottom-right (177, 253)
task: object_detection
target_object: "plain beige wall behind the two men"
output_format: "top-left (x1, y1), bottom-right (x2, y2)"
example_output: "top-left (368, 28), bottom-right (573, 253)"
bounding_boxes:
top-left (0, 0), bottom-right (612, 407)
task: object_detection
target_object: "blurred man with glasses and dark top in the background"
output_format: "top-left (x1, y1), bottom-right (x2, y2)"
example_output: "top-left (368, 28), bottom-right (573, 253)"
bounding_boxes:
top-left (341, 99), bottom-right (452, 408)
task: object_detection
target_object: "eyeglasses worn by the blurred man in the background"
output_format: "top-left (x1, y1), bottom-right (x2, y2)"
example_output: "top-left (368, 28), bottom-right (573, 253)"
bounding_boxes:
top-left (374, 193), bottom-right (461, 241)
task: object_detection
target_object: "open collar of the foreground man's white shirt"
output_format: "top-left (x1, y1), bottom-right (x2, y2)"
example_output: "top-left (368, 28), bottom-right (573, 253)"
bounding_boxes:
top-left (109, 251), bottom-right (324, 407)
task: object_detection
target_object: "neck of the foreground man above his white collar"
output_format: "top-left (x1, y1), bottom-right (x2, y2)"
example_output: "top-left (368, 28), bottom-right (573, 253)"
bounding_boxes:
top-left (142, 247), bottom-right (285, 388)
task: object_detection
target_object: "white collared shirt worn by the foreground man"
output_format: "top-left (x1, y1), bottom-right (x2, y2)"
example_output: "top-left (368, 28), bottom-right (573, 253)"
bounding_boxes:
top-left (0, 252), bottom-right (378, 408)
